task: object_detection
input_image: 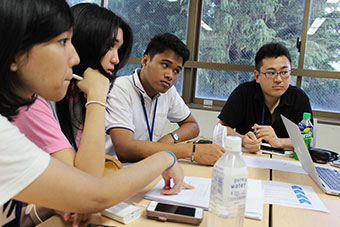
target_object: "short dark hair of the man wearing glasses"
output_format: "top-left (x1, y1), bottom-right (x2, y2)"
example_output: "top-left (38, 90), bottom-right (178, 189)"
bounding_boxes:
top-left (255, 43), bottom-right (291, 72)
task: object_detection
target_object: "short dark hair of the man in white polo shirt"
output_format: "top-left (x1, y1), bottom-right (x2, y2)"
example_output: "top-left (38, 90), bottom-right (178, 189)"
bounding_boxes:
top-left (144, 33), bottom-right (190, 65)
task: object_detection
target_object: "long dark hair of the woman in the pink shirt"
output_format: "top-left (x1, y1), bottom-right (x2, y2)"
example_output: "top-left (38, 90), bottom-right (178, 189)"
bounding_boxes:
top-left (56, 3), bottom-right (133, 150)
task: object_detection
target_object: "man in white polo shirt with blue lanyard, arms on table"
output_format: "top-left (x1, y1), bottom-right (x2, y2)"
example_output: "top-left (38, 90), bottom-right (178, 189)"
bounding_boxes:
top-left (106, 33), bottom-right (224, 165)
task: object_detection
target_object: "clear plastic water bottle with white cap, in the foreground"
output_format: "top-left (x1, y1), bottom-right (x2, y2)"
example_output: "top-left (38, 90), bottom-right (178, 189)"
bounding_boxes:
top-left (208, 136), bottom-right (248, 227)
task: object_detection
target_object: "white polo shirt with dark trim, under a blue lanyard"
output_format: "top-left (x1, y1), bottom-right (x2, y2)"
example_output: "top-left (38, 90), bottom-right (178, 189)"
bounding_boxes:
top-left (105, 69), bottom-right (191, 155)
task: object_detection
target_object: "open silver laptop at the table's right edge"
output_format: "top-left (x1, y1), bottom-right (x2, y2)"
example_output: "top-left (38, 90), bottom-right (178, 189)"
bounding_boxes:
top-left (281, 115), bottom-right (340, 196)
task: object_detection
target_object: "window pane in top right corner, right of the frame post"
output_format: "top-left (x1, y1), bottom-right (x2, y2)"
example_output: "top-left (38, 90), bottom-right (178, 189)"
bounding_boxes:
top-left (304, 0), bottom-right (340, 71)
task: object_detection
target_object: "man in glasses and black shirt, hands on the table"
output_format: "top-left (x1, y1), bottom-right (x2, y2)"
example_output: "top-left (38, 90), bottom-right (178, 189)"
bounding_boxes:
top-left (218, 43), bottom-right (312, 152)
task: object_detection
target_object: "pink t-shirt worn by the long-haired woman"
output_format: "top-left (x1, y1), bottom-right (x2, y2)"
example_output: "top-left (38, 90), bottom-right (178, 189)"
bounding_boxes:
top-left (13, 97), bottom-right (72, 154)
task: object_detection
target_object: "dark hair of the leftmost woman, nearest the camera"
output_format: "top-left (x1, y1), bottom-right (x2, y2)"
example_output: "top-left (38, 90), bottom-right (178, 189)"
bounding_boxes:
top-left (0, 0), bottom-right (73, 120)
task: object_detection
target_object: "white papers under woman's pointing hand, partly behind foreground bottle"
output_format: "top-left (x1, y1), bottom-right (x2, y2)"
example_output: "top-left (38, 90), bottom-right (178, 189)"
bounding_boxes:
top-left (144, 176), bottom-right (264, 220)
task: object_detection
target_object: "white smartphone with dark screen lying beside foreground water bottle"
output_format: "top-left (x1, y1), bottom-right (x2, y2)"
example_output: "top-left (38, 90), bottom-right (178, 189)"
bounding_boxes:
top-left (146, 201), bottom-right (204, 225)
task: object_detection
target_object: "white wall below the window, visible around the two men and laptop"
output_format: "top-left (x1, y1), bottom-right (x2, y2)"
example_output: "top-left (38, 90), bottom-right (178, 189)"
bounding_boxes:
top-left (164, 109), bottom-right (340, 153)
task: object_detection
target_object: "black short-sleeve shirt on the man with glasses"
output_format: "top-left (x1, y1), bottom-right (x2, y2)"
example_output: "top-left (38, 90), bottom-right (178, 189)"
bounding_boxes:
top-left (218, 80), bottom-right (313, 138)
